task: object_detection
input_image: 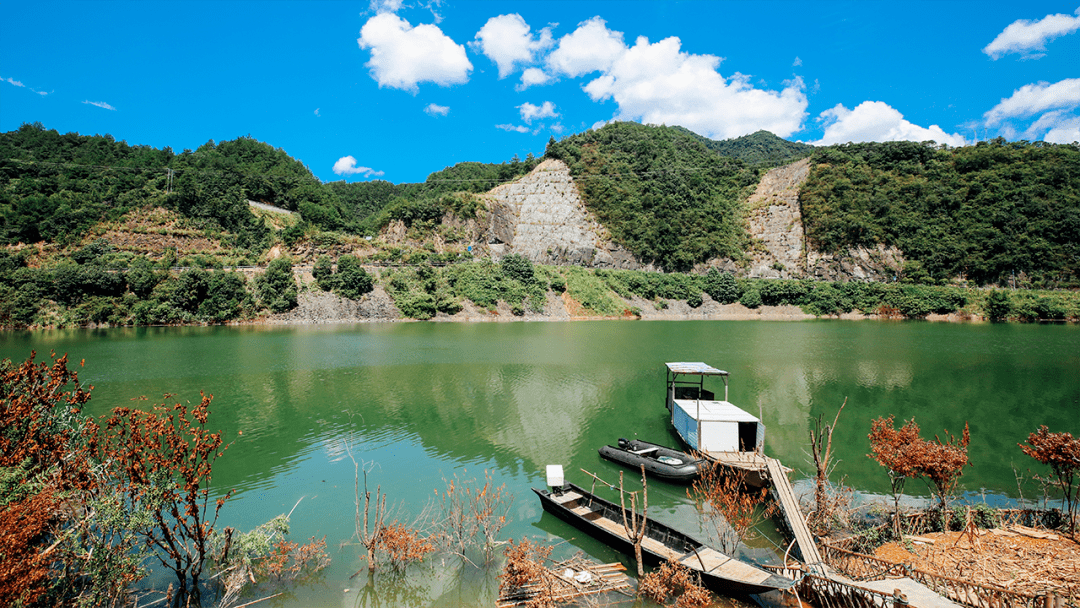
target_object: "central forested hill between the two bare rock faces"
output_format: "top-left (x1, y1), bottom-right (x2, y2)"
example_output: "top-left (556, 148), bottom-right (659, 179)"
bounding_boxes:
top-left (546, 122), bottom-right (759, 271)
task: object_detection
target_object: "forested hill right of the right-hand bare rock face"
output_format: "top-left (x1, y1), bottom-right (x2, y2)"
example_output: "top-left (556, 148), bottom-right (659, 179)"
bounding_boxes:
top-left (799, 139), bottom-right (1080, 287)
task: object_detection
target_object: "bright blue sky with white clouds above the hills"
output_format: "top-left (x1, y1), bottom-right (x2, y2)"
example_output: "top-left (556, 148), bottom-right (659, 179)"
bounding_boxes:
top-left (0, 0), bottom-right (1080, 183)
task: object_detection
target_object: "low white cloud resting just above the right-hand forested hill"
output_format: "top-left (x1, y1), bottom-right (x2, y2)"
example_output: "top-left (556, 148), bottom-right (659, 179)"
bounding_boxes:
top-left (812, 102), bottom-right (968, 146)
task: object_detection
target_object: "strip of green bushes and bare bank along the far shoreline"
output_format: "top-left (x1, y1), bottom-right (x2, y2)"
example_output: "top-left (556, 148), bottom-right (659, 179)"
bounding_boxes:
top-left (0, 252), bottom-right (1080, 329)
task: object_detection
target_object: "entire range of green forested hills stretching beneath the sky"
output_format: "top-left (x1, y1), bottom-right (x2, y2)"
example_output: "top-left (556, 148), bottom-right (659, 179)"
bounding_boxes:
top-left (0, 122), bottom-right (1080, 287)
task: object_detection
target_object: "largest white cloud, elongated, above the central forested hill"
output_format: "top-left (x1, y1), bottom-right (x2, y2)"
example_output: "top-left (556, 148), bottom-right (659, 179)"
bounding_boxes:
top-left (584, 37), bottom-right (808, 138)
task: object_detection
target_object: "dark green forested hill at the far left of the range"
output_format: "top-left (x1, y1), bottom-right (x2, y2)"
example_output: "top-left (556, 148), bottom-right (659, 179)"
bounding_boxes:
top-left (0, 124), bottom-right (330, 248)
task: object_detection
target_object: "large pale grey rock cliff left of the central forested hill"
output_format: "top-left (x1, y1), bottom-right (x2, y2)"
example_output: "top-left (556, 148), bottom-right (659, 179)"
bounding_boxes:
top-left (484, 159), bottom-right (643, 269)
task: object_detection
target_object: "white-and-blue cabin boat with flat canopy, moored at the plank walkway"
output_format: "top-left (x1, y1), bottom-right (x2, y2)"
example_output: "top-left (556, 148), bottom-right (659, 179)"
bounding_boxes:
top-left (666, 363), bottom-right (765, 454)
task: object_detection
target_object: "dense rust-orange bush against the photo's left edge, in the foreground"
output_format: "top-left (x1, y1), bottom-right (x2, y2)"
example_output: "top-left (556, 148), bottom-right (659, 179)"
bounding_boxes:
top-left (0, 353), bottom-right (145, 606)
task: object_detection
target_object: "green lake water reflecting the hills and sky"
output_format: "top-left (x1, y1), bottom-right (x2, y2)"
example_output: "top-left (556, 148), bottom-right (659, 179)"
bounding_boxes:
top-left (0, 321), bottom-right (1080, 606)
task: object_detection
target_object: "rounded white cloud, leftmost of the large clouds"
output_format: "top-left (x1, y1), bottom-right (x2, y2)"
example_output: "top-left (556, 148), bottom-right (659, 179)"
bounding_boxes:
top-left (356, 13), bottom-right (473, 93)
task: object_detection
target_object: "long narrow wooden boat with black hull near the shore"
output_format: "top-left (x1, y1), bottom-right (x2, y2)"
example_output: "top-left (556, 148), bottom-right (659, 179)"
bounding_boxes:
top-left (532, 484), bottom-right (794, 595)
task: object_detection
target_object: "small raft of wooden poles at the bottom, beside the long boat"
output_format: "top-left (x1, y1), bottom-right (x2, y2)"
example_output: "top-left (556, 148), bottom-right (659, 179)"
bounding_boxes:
top-left (495, 554), bottom-right (633, 608)
